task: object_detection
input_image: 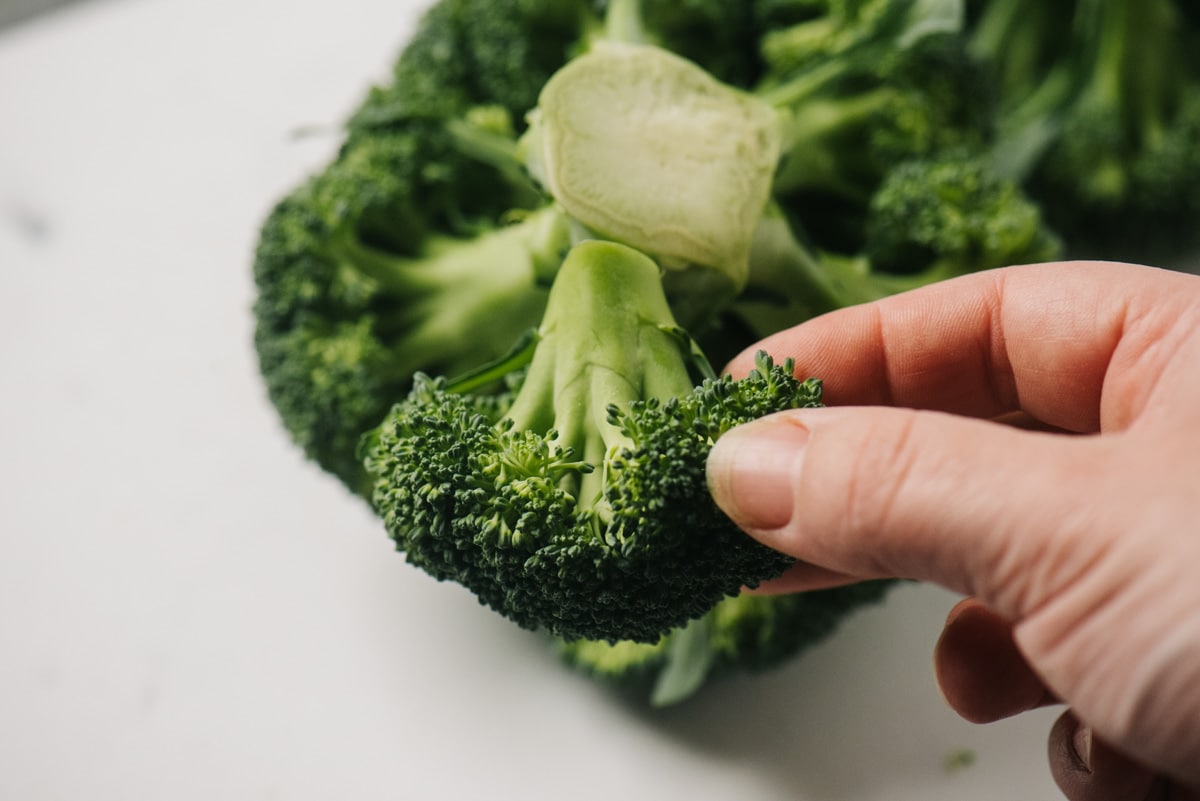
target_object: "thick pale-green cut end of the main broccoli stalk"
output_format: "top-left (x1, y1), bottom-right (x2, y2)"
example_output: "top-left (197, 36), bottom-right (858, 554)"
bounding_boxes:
top-left (526, 42), bottom-right (780, 288)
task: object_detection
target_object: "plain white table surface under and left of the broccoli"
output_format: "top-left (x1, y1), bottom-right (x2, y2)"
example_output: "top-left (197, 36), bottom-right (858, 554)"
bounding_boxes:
top-left (0, 0), bottom-right (1058, 801)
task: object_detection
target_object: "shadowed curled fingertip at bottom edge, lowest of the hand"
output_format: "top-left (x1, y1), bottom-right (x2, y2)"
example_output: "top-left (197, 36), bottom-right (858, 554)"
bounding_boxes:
top-left (1049, 711), bottom-right (1170, 801)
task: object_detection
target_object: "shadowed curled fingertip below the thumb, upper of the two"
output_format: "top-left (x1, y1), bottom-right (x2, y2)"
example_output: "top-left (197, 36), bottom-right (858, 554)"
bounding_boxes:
top-left (934, 598), bottom-right (1057, 723)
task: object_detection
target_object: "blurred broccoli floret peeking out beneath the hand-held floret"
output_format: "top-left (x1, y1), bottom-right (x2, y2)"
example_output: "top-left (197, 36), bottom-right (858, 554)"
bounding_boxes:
top-left (556, 582), bottom-right (894, 706)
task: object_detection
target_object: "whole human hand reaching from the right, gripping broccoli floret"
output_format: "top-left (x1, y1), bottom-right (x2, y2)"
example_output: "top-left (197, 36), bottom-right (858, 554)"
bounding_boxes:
top-left (709, 263), bottom-right (1200, 801)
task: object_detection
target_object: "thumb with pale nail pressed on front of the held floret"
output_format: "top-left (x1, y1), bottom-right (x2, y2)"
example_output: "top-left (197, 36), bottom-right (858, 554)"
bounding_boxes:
top-left (708, 408), bottom-right (1111, 620)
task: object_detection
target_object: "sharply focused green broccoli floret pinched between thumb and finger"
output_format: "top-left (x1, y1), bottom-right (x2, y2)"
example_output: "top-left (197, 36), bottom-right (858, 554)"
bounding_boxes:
top-left (367, 241), bottom-right (820, 642)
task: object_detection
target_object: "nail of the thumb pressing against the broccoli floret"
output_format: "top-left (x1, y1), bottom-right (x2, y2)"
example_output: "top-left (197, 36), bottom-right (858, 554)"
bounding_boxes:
top-left (708, 418), bottom-right (809, 529)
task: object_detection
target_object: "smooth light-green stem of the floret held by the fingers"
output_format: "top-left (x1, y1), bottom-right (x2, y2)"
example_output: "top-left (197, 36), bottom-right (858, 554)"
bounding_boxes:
top-left (506, 240), bottom-right (694, 504)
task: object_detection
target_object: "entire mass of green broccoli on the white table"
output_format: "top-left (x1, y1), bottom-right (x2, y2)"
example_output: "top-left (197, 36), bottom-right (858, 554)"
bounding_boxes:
top-left (254, 0), bottom-right (1200, 703)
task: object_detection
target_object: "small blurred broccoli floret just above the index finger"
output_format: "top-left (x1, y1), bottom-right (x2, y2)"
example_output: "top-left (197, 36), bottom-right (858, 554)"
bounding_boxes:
top-left (734, 152), bottom-right (1061, 337)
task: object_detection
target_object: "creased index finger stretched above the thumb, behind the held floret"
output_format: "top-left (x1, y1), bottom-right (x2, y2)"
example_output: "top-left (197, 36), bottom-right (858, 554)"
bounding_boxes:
top-left (728, 263), bottom-right (1200, 432)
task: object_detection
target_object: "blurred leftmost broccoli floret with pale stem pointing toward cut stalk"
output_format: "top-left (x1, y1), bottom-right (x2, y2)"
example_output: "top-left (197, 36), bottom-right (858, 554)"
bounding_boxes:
top-left (254, 107), bottom-right (568, 492)
